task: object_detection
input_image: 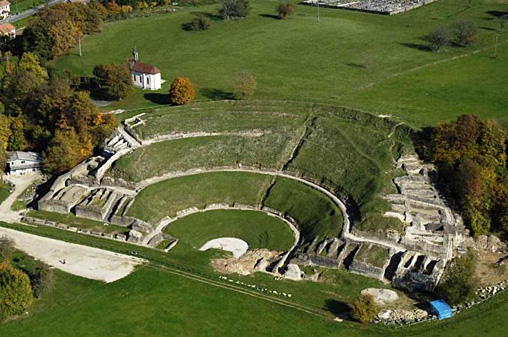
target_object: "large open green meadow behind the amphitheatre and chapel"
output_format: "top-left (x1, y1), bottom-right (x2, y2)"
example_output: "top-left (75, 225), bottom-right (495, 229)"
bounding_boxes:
top-left (55, 0), bottom-right (508, 125)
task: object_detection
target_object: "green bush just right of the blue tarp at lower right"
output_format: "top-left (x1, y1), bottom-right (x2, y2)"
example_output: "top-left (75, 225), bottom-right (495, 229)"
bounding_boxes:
top-left (438, 251), bottom-right (478, 304)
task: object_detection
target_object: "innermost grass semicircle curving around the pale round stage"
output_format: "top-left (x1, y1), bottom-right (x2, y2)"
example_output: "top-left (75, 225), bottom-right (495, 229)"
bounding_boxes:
top-left (164, 210), bottom-right (294, 251)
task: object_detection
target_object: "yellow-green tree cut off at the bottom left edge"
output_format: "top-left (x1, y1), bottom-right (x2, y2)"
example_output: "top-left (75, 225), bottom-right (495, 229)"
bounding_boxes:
top-left (0, 264), bottom-right (33, 320)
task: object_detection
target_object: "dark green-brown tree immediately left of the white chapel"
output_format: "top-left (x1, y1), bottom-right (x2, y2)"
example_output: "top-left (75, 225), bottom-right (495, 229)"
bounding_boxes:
top-left (93, 63), bottom-right (132, 100)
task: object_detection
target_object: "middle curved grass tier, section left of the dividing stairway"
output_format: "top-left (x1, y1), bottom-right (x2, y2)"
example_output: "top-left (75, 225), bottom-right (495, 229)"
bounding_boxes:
top-left (127, 172), bottom-right (272, 225)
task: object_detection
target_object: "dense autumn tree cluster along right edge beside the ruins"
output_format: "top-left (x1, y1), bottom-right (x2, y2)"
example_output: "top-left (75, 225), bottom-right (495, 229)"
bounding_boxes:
top-left (419, 115), bottom-right (508, 237)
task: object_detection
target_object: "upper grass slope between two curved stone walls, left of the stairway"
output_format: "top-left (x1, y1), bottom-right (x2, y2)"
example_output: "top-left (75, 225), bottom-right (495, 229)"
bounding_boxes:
top-left (108, 131), bottom-right (297, 182)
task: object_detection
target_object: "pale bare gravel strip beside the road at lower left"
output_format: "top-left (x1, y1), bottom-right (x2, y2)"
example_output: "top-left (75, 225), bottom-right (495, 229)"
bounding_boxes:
top-left (0, 227), bottom-right (144, 283)
